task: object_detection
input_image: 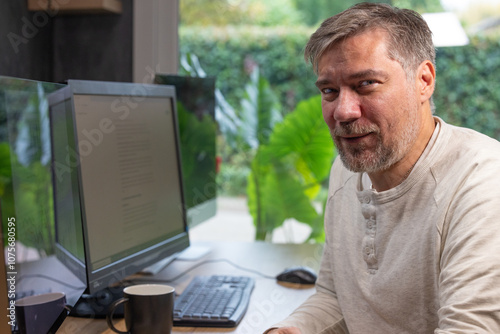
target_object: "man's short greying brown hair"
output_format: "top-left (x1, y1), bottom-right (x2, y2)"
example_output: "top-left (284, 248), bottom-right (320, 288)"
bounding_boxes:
top-left (304, 3), bottom-right (436, 79)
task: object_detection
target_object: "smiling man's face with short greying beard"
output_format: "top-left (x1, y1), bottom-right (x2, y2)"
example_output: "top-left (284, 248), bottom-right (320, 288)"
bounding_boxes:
top-left (316, 29), bottom-right (421, 173)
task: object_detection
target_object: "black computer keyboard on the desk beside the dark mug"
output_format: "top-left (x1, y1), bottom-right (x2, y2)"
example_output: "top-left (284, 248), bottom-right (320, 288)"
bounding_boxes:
top-left (174, 275), bottom-right (254, 327)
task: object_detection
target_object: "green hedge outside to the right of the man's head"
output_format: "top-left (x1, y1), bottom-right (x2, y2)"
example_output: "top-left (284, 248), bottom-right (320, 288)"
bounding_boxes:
top-left (434, 38), bottom-right (500, 140)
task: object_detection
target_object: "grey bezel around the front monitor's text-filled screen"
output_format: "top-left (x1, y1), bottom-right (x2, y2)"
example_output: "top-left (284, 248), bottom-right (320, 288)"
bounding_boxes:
top-left (48, 80), bottom-right (190, 294)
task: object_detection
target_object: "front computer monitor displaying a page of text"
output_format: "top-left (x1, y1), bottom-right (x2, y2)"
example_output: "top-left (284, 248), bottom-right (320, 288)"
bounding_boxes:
top-left (49, 80), bottom-right (189, 316)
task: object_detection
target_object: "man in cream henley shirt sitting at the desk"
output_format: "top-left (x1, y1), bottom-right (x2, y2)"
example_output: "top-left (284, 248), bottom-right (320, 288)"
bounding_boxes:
top-left (269, 3), bottom-right (500, 334)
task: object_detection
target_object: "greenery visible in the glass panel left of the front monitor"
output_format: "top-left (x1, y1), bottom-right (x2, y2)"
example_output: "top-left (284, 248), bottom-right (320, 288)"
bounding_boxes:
top-left (0, 76), bottom-right (63, 255)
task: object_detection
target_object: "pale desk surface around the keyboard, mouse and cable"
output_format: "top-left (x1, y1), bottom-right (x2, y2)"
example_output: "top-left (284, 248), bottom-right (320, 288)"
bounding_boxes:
top-left (57, 242), bottom-right (322, 334)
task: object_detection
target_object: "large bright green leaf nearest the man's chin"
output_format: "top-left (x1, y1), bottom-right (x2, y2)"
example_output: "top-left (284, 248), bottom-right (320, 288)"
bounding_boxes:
top-left (247, 97), bottom-right (335, 240)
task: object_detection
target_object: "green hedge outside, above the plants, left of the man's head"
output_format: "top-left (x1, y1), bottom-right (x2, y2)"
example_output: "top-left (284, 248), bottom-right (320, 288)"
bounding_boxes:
top-left (179, 27), bottom-right (317, 114)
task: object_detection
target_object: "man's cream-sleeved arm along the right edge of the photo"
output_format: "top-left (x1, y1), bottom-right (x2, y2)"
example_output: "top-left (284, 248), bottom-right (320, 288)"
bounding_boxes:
top-left (435, 151), bottom-right (500, 334)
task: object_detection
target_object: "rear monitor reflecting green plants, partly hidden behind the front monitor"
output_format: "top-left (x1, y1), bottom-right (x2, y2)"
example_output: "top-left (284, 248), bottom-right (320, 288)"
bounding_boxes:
top-left (155, 74), bottom-right (217, 227)
